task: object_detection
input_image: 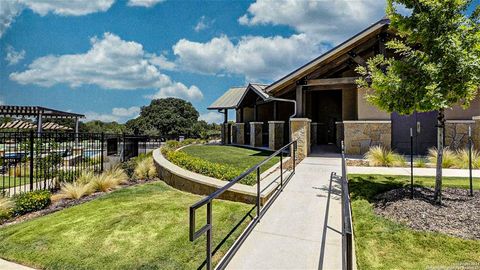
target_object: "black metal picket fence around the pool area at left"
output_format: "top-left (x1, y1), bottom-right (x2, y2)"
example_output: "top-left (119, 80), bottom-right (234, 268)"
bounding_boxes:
top-left (0, 131), bottom-right (162, 196)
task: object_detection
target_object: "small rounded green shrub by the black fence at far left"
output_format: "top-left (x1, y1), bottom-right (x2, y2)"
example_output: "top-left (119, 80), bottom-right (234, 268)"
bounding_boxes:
top-left (13, 190), bottom-right (51, 216)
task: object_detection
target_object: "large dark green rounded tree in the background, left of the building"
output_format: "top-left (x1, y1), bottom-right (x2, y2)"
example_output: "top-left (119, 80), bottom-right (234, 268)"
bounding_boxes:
top-left (126, 98), bottom-right (199, 138)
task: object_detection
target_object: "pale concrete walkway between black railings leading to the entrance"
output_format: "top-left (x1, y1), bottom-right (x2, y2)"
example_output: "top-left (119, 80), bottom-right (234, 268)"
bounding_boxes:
top-left (227, 156), bottom-right (342, 269)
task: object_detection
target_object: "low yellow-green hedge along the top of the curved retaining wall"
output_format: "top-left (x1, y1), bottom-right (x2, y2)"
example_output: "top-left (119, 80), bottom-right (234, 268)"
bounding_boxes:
top-left (165, 151), bottom-right (256, 185)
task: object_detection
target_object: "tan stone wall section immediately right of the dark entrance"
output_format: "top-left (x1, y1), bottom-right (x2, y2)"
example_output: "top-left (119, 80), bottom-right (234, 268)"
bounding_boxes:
top-left (343, 121), bottom-right (392, 155)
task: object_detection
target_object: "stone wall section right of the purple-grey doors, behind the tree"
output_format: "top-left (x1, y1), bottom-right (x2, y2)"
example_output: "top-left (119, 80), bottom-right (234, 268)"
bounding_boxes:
top-left (445, 120), bottom-right (475, 149)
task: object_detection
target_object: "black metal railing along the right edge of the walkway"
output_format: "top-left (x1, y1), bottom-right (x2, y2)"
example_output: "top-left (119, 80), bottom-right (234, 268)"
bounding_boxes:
top-left (340, 141), bottom-right (354, 270)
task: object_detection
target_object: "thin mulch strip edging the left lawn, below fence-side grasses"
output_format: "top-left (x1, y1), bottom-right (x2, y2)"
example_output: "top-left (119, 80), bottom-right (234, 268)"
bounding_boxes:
top-left (0, 179), bottom-right (158, 228)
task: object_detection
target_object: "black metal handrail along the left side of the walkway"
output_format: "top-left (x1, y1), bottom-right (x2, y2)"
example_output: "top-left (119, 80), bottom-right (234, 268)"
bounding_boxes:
top-left (189, 141), bottom-right (297, 270)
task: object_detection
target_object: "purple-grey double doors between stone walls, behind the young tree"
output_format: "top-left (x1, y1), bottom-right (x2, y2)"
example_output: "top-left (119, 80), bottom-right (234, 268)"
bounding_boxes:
top-left (392, 111), bottom-right (437, 155)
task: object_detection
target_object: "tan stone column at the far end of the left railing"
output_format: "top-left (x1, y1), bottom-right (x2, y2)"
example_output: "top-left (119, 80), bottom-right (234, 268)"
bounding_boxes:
top-left (290, 118), bottom-right (312, 160)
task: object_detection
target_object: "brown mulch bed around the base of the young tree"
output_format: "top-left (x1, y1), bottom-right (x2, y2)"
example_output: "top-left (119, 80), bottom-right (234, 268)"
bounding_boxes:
top-left (374, 187), bottom-right (480, 240)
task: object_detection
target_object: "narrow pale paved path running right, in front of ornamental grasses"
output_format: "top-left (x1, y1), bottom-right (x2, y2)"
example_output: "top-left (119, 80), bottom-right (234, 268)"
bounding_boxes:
top-left (347, 166), bottom-right (480, 177)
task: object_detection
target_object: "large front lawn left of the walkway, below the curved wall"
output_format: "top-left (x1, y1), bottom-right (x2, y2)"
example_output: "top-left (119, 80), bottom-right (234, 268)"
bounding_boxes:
top-left (0, 182), bottom-right (252, 269)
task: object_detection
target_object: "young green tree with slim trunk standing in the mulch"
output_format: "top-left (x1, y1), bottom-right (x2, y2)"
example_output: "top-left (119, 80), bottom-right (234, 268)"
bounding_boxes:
top-left (357, 0), bottom-right (480, 204)
